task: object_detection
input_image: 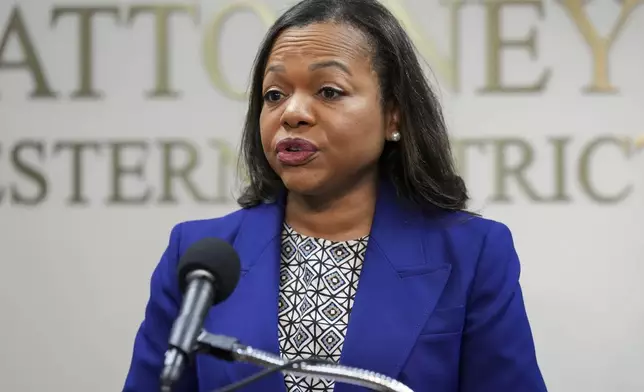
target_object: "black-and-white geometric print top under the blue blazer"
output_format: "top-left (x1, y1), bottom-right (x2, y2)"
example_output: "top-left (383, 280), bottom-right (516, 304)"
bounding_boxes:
top-left (278, 223), bottom-right (369, 392)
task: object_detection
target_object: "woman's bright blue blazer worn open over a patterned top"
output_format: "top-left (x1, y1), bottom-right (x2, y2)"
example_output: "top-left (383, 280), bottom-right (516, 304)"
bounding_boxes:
top-left (123, 186), bottom-right (546, 392)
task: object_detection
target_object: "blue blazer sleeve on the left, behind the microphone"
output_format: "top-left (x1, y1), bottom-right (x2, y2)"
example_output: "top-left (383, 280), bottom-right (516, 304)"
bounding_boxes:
top-left (123, 225), bottom-right (197, 392)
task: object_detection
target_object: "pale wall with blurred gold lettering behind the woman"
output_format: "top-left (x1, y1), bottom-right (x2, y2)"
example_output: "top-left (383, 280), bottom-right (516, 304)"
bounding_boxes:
top-left (0, 0), bottom-right (644, 392)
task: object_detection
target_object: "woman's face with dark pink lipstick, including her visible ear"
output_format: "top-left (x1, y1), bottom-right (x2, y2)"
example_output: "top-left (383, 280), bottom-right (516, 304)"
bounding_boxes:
top-left (260, 23), bottom-right (397, 196)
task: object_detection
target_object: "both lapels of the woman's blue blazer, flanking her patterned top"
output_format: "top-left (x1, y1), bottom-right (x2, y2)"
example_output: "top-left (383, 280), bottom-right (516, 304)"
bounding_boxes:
top-left (226, 182), bottom-right (450, 392)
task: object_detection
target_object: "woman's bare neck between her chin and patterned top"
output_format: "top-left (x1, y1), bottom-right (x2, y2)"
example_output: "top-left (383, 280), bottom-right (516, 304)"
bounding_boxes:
top-left (286, 175), bottom-right (377, 241)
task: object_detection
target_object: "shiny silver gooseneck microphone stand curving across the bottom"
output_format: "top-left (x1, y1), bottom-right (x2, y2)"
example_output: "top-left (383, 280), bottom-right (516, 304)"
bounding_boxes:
top-left (196, 331), bottom-right (413, 392)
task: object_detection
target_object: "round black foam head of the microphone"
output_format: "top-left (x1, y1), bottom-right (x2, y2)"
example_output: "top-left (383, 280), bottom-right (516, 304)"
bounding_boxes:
top-left (177, 238), bottom-right (241, 305)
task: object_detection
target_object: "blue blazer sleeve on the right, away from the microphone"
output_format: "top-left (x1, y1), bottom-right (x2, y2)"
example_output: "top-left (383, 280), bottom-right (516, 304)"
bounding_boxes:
top-left (460, 223), bottom-right (547, 392)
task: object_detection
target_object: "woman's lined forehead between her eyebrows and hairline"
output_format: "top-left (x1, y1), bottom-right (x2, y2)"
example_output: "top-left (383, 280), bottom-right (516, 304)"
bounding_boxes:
top-left (268, 23), bottom-right (370, 67)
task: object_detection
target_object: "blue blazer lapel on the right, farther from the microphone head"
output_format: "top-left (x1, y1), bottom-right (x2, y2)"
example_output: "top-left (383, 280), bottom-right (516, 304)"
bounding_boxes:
top-left (335, 185), bottom-right (451, 392)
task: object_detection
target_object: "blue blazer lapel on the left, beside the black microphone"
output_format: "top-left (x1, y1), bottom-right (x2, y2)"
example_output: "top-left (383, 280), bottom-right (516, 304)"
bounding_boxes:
top-left (208, 202), bottom-right (286, 392)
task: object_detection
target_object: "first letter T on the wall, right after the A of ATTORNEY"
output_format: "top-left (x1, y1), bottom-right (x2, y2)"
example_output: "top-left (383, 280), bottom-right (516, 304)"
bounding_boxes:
top-left (51, 6), bottom-right (119, 98)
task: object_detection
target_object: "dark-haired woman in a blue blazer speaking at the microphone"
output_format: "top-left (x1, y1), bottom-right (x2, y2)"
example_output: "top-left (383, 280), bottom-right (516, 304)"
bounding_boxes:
top-left (124, 0), bottom-right (546, 392)
